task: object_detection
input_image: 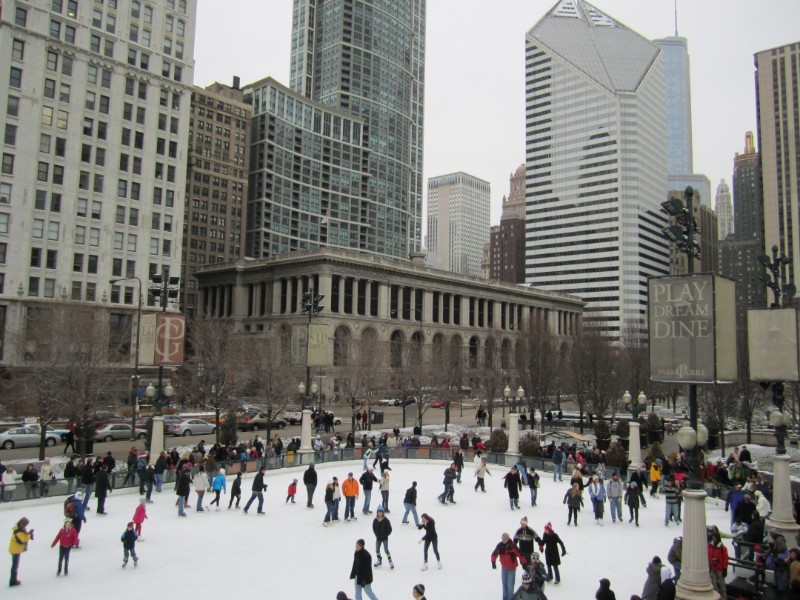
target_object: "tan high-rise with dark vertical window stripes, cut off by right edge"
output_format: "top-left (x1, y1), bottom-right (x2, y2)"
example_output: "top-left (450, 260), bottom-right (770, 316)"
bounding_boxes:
top-left (755, 43), bottom-right (800, 283)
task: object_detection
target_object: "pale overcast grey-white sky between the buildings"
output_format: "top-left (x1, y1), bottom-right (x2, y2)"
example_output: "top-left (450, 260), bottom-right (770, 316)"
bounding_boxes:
top-left (194, 0), bottom-right (800, 224)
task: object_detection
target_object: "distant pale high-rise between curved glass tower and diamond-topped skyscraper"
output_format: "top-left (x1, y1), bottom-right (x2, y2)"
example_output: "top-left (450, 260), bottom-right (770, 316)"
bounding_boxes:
top-left (428, 173), bottom-right (491, 277)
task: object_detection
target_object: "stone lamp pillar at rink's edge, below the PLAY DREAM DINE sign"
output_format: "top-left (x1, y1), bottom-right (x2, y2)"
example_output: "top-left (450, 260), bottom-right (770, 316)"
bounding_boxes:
top-left (676, 490), bottom-right (719, 600)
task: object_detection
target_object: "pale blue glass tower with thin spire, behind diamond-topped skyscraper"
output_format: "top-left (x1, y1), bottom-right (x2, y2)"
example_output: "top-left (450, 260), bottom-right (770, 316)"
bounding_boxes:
top-left (654, 31), bottom-right (711, 207)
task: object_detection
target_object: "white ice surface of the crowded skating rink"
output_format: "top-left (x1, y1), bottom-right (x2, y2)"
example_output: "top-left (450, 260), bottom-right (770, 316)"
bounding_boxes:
top-left (0, 460), bottom-right (729, 600)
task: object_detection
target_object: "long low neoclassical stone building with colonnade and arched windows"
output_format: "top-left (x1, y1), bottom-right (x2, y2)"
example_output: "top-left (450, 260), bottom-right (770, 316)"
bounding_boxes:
top-left (196, 247), bottom-right (585, 391)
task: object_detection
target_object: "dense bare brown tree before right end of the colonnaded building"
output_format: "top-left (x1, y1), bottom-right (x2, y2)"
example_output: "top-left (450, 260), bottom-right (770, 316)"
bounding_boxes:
top-left (512, 319), bottom-right (559, 432)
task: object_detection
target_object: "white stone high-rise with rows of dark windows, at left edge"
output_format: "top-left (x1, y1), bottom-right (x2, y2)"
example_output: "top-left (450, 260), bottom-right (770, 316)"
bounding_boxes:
top-left (0, 0), bottom-right (196, 360)
